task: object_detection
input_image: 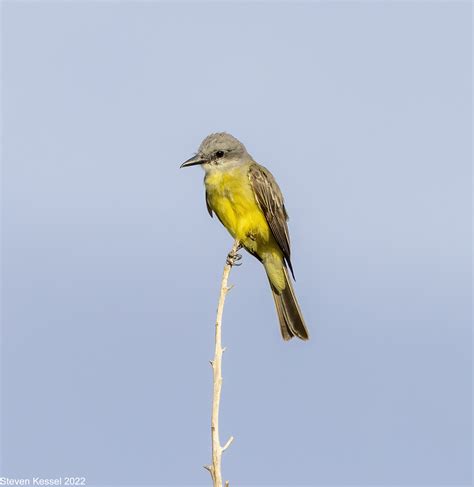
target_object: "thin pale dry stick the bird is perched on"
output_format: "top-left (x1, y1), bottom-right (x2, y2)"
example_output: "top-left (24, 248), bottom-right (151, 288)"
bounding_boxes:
top-left (204, 240), bottom-right (239, 487)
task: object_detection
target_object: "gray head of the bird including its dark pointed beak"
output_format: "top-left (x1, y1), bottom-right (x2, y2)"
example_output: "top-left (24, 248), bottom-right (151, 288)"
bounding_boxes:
top-left (181, 132), bottom-right (250, 171)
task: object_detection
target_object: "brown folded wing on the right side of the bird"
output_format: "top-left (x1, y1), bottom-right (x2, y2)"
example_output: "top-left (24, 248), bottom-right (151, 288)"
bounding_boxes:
top-left (248, 163), bottom-right (295, 278)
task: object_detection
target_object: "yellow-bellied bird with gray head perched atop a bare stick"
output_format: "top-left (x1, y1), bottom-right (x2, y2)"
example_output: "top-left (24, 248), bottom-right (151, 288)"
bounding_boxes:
top-left (180, 132), bottom-right (309, 341)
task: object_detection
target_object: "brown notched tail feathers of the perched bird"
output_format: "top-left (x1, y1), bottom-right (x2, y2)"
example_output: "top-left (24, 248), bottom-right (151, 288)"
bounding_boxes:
top-left (268, 266), bottom-right (309, 340)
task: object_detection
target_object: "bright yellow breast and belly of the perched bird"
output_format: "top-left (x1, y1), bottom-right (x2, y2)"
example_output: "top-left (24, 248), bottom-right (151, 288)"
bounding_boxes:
top-left (204, 165), bottom-right (271, 250)
